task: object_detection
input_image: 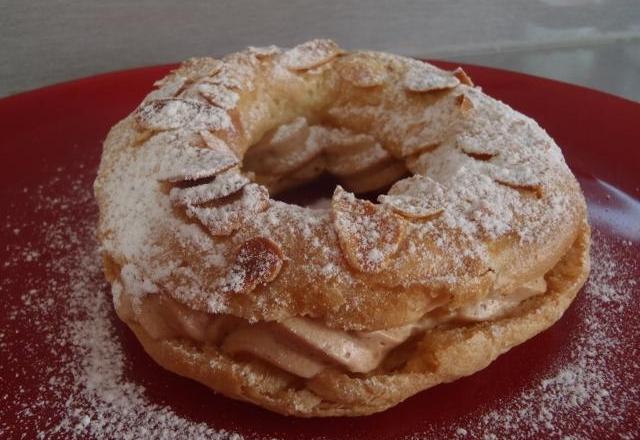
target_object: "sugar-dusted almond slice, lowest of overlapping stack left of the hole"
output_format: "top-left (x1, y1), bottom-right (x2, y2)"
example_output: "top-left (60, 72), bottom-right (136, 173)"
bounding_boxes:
top-left (186, 183), bottom-right (269, 236)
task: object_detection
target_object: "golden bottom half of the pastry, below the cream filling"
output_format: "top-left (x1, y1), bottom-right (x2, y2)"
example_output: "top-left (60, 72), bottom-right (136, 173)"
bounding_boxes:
top-left (116, 224), bottom-right (590, 417)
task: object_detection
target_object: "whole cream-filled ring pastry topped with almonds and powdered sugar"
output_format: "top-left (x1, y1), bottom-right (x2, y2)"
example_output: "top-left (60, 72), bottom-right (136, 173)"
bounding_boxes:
top-left (95, 40), bottom-right (589, 416)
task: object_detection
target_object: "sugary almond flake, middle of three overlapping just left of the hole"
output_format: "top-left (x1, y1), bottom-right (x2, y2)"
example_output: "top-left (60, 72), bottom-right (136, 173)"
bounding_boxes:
top-left (169, 168), bottom-right (250, 206)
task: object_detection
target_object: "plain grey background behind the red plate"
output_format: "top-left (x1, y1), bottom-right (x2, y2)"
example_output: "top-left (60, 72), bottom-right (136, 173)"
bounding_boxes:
top-left (0, 0), bottom-right (640, 99)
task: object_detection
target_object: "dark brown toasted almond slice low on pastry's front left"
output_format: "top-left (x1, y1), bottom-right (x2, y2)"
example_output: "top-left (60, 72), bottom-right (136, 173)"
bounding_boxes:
top-left (220, 237), bottom-right (283, 294)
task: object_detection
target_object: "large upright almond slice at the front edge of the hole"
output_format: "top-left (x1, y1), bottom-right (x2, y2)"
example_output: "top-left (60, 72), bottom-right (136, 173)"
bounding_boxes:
top-left (331, 186), bottom-right (404, 273)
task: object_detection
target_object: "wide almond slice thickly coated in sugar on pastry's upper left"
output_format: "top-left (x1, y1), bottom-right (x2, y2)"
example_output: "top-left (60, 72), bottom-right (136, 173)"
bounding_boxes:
top-left (134, 98), bottom-right (232, 131)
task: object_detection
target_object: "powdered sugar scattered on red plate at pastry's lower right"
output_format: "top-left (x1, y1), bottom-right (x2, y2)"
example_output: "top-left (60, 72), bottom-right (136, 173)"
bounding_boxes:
top-left (408, 230), bottom-right (640, 439)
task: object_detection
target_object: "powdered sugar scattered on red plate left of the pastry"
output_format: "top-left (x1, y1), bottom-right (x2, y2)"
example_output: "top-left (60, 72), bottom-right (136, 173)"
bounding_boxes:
top-left (0, 170), bottom-right (242, 440)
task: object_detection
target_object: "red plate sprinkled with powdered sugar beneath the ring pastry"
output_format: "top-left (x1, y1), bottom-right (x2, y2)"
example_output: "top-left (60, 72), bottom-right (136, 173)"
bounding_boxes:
top-left (0, 63), bottom-right (640, 440)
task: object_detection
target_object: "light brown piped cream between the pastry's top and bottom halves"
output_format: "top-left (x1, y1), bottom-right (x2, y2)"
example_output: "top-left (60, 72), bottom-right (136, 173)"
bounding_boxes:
top-left (117, 278), bottom-right (546, 378)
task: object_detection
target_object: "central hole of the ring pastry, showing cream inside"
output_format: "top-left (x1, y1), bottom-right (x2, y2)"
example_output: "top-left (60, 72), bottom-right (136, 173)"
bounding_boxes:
top-left (243, 116), bottom-right (409, 207)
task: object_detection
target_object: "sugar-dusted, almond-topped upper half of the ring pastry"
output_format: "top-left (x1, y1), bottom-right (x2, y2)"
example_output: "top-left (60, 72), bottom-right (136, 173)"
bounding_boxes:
top-left (95, 40), bottom-right (585, 331)
